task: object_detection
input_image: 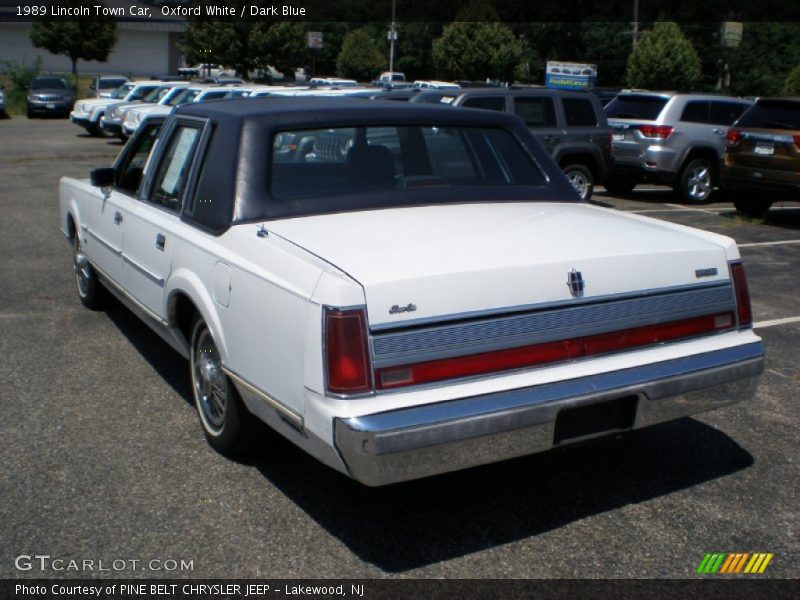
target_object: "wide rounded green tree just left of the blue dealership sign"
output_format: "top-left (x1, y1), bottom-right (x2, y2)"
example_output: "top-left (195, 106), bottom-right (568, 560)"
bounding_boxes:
top-left (433, 21), bottom-right (524, 81)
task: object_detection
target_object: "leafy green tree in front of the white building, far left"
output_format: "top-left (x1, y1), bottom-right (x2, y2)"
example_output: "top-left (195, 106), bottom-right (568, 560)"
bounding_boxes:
top-left (30, 0), bottom-right (117, 82)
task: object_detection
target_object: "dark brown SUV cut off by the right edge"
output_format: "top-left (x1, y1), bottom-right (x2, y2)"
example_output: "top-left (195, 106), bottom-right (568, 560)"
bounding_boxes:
top-left (722, 98), bottom-right (800, 217)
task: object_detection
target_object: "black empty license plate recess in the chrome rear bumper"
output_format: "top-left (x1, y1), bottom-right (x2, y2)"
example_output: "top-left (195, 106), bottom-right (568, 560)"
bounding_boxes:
top-left (553, 396), bottom-right (639, 446)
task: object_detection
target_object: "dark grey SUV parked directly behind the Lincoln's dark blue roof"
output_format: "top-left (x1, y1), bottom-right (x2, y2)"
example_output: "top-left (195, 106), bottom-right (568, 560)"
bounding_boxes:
top-left (410, 87), bottom-right (614, 200)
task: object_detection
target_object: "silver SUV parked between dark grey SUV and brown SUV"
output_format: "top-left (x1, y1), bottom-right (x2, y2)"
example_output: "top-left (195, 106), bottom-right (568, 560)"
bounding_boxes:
top-left (605, 91), bottom-right (752, 203)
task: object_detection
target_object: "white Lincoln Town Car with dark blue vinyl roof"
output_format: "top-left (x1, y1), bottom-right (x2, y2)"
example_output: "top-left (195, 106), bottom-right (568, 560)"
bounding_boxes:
top-left (59, 97), bottom-right (764, 485)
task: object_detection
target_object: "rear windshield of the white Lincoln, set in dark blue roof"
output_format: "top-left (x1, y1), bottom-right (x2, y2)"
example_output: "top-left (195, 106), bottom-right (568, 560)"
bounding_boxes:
top-left (271, 125), bottom-right (546, 200)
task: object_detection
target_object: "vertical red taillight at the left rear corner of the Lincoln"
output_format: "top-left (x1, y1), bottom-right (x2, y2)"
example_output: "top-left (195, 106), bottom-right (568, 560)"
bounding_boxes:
top-left (325, 309), bottom-right (372, 394)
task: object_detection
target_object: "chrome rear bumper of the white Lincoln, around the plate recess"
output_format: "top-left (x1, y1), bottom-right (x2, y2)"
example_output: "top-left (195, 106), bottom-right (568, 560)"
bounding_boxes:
top-left (334, 342), bottom-right (764, 485)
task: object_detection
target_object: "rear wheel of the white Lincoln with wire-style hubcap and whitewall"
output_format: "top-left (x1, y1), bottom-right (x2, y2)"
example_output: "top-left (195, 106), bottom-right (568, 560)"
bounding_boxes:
top-left (189, 316), bottom-right (254, 456)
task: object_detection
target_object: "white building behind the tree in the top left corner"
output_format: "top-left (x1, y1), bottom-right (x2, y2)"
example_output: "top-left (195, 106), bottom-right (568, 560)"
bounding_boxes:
top-left (0, 0), bottom-right (186, 77)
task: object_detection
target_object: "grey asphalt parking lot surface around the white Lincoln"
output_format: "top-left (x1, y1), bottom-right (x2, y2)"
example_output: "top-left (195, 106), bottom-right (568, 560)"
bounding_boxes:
top-left (0, 118), bottom-right (800, 578)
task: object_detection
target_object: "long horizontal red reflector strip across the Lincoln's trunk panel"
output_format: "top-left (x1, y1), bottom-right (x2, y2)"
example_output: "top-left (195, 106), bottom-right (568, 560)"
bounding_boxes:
top-left (376, 312), bottom-right (734, 390)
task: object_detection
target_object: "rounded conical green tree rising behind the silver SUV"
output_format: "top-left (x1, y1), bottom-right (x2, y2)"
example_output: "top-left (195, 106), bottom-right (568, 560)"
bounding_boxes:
top-left (627, 21), bottom-right (700, 90)
